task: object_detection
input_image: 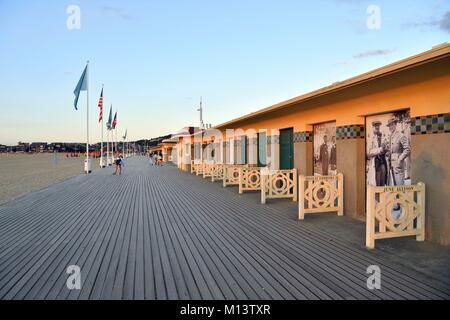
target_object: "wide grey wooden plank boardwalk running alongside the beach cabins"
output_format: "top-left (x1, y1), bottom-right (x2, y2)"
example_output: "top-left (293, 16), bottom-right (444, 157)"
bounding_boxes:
top-left (0, 158), bottom-right (450, 299)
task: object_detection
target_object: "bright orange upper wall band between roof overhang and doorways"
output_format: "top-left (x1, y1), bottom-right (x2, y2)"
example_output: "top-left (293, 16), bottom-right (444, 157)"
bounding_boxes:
top-left (223, 74), bottom-right (450, 132)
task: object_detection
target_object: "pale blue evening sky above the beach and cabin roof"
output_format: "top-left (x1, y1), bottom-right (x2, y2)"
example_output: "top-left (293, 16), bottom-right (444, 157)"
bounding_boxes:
top-left (0, 0), bottom-right (450, 145)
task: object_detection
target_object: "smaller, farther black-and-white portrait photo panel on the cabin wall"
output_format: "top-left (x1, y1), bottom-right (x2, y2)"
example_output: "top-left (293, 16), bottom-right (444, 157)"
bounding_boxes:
top-left (314, 122), bottom-right (337, 176)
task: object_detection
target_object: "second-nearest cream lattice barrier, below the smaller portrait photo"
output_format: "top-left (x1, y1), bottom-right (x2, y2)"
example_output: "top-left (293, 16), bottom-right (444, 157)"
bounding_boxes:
top-left (298, 173), bottom-right (344, 220)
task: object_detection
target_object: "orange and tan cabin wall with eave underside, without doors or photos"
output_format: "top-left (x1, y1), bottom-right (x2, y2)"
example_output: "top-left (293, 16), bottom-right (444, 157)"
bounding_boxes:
top-left (215, 58), bottom-right (450, 245)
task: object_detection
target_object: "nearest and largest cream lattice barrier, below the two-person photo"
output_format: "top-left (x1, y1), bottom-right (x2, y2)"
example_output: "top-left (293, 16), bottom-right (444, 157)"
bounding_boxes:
top-left (366, 183), bottom-right (425, 249)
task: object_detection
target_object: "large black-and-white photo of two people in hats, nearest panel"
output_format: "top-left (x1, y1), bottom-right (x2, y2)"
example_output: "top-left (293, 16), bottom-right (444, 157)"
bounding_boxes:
top-left (366, 110), bottom-right (411, 187)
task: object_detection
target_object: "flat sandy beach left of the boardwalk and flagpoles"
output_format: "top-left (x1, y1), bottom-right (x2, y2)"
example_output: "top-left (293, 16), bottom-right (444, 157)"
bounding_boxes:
top-left (0, 153), bottom-right (98, 204)
